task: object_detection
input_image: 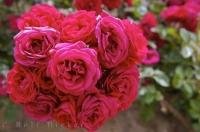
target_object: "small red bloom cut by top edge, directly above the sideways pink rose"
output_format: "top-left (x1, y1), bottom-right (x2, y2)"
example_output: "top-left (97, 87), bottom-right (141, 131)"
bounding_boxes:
top-left (102, 0), bottom-right (122, 9)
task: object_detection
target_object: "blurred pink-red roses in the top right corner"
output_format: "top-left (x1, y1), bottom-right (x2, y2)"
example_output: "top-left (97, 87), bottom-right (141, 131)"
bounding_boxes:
top-left (160, 0), bottom-right (200, 32)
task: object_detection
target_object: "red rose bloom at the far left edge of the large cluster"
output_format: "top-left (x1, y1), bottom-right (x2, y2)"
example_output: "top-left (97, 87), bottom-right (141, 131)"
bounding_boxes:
top-left (7, 64), bottom-right (38, 104)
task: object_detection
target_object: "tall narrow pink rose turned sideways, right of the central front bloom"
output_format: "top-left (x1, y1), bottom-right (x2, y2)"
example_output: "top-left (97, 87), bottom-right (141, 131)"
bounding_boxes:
top-left (95, 16), bottom-right (129, 68)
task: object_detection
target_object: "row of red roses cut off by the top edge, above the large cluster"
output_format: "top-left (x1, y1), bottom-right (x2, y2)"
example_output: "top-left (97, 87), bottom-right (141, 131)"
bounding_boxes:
top-left (73, 0), bottom-right (133, 13)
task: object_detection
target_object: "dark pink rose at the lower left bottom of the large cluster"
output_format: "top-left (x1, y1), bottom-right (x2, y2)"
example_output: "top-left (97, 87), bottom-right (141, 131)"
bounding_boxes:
top-left (24, 93), bottom-right (57, 122)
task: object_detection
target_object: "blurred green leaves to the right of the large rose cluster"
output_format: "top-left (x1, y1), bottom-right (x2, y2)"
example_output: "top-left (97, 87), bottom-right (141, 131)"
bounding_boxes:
top-left (138, 0), bottom-right (200, 131)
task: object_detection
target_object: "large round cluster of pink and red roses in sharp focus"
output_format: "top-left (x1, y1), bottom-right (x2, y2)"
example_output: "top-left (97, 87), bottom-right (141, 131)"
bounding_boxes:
top-left (8, 4), bottom-right (147, 131)
